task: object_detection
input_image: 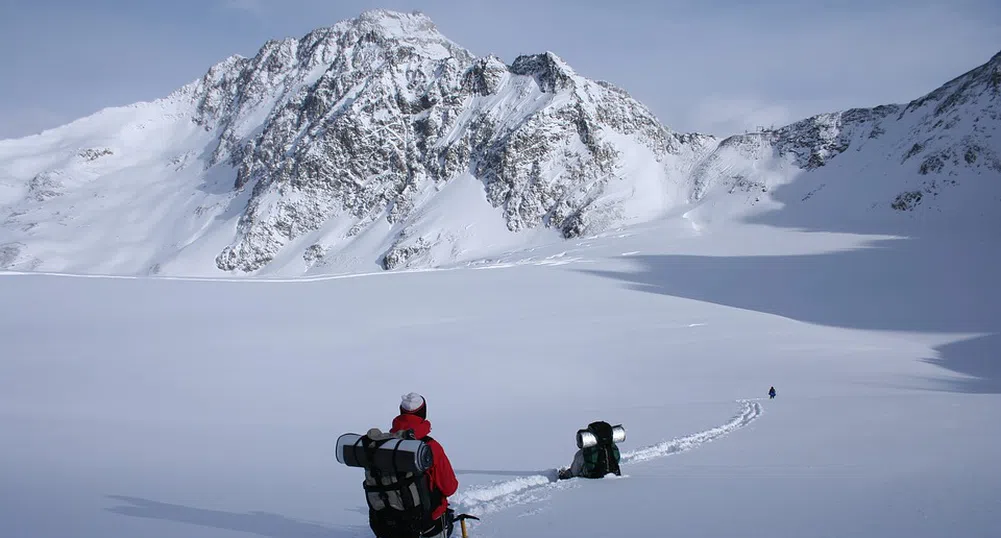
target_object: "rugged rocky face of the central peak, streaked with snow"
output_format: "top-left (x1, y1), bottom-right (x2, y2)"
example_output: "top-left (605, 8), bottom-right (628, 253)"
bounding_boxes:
top-left (188, 11), bottom-right (704, 272)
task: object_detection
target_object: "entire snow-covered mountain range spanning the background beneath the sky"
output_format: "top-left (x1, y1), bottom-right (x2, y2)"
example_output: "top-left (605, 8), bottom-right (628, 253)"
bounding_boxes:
top-left (0, 10), bottom-right (1001, 276)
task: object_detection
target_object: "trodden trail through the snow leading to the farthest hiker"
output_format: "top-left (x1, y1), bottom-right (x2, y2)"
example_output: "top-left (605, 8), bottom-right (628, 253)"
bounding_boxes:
top-left (451, 400), bottom-right (762, 516)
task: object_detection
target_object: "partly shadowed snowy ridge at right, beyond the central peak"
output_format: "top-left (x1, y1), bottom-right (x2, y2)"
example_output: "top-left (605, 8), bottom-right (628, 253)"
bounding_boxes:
top-left (691, 53), bottom-right (1001, 229)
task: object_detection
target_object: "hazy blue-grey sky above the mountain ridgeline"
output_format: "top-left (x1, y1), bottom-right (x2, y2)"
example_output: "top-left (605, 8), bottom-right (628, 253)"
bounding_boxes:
top-left (0, 0), bottom-right (1001, 138)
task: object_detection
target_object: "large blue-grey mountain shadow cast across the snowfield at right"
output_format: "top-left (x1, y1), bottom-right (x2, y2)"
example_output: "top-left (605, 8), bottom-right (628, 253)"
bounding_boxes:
top-left (583, 168), bottom-right (1001, 394)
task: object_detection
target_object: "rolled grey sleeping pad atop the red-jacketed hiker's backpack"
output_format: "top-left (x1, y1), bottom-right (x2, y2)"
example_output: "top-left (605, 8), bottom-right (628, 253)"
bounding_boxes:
top-left (335, 434), bottom-right (434, 473)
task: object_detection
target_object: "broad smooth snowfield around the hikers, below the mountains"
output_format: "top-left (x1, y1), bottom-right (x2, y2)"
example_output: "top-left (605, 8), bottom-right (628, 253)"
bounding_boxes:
top-left (0, 208), bottom-right (1001, 538)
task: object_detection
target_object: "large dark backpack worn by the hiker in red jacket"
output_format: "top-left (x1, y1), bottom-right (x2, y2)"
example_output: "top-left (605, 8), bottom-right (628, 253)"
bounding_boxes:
top-left (342, 428), bottom-right (441, 538)
